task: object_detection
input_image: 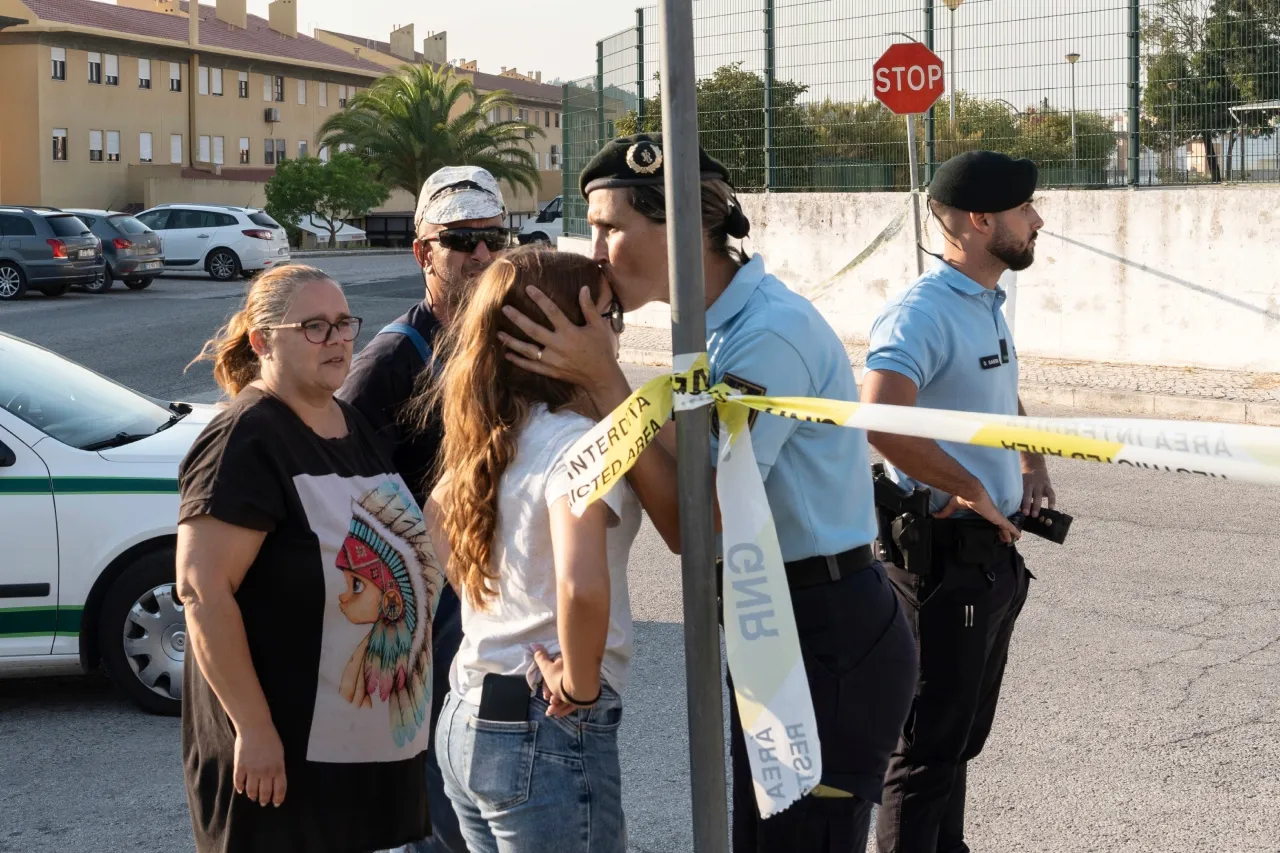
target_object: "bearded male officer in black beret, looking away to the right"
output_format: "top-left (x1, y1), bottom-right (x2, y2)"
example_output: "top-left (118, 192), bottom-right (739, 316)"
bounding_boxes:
top-left (863, 151), bottom-right (1053, 853)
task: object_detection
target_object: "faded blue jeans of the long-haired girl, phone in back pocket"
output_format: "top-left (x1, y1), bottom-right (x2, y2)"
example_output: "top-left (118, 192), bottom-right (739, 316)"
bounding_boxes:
top-left (435, 686), bottom-right (627, 853)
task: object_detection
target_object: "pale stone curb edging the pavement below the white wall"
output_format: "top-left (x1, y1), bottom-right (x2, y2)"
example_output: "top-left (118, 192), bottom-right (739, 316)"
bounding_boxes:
top-left (618, 347), bottom-right (1280, 427)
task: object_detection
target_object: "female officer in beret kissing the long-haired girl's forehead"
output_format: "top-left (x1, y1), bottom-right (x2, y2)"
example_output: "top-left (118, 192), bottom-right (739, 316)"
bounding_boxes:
top-left (491, 134), bottom-right (916, 853)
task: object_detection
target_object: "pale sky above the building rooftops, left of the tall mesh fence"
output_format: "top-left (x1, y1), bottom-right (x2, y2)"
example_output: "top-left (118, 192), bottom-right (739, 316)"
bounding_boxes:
top-left (239, 0), bottom-right (641, 81)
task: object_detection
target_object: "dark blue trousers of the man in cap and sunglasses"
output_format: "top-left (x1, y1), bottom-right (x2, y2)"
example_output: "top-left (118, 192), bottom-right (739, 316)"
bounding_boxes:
top-left (383, 585), bottom-right (467, 853)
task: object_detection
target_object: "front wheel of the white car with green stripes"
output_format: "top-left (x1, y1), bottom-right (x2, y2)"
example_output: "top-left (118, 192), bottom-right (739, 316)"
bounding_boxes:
top-left (97, 548), bottom-right (187, 715)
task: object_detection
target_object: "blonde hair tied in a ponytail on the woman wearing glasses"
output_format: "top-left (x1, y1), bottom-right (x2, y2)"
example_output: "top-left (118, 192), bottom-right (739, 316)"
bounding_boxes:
top-left (187, 264), bottom-right (329, 397)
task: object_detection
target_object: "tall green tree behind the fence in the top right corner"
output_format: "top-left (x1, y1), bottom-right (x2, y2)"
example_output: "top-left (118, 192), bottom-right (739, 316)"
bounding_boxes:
top-left (1140, 0), bottom-right (1280, 182)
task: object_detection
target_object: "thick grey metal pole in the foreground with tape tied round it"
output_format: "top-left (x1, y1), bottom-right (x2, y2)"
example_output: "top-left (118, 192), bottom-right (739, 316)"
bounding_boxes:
top-left (658, 0), bottom-right (728, 853)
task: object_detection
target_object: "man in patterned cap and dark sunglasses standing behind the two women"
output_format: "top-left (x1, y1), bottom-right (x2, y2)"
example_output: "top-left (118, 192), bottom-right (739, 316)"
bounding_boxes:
top-left (338, 167), bottom-right (507, 853)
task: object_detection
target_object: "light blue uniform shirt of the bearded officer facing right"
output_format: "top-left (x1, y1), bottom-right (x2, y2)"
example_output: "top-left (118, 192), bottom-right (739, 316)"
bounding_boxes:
top-left (867, 260), bottom-right (1023, 516)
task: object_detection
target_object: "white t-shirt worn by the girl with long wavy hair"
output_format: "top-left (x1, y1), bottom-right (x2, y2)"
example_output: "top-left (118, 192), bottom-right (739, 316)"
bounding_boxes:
top-left (449, 406), bottom-right (640, 704)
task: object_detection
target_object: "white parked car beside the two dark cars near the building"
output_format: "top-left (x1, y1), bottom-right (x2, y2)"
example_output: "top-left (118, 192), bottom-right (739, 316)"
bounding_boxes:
top-left (136, 204), bottom-right (289, 282)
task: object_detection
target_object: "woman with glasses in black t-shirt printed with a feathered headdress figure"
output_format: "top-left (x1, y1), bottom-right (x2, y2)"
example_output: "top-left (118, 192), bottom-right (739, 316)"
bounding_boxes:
top-left (178, 265), bottom-right (444, 853)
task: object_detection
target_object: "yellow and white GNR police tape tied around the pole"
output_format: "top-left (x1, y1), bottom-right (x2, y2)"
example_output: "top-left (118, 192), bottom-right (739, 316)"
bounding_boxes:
top-left (566, 353), bottom-right (1280, 817)
